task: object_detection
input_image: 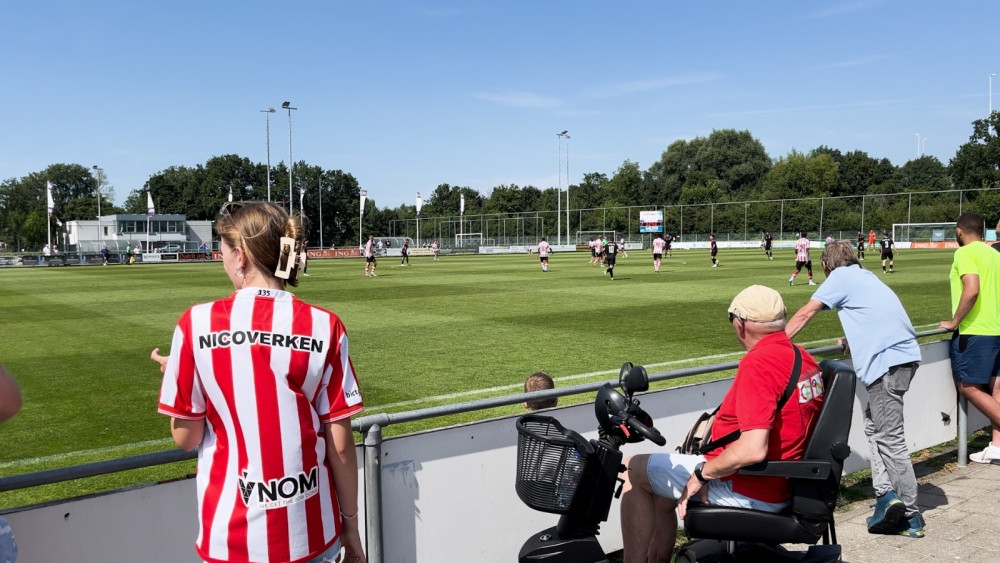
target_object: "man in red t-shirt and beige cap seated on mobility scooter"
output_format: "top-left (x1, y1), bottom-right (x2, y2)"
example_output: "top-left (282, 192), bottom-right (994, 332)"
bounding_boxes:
top-left (621, 285), bottom-right (824, 563)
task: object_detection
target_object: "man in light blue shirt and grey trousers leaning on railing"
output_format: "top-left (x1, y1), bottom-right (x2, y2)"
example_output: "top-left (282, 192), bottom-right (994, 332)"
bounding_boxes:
top-left (785, 242), bottom-right (924, 538)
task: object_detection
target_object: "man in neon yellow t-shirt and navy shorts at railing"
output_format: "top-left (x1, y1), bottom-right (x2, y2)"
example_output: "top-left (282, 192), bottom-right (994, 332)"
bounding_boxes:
top-left (940, 213), bottom-right (1000, 465)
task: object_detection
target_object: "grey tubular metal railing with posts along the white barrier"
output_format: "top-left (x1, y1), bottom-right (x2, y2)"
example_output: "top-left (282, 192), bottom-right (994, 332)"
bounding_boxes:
top-left (0, 329), bottom-right (968, 563)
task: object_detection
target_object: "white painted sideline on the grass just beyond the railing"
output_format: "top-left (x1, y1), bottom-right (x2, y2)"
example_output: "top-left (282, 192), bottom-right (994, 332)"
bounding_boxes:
top-left (0, 324), bottom-right (937, 470)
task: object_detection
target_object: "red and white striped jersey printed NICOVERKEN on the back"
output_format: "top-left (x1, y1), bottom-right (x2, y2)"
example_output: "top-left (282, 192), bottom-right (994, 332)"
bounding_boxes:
top-left (159, 287), bottom-right (364, 563)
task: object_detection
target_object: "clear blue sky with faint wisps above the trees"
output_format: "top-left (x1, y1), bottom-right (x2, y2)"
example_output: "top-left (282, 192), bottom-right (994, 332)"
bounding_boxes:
top-left (0, 0), bottom-right (1000, 206)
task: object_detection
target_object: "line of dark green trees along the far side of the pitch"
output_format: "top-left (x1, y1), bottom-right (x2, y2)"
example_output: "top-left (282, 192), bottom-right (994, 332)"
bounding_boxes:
top-left (0, 111), bottom-right (1000, 246)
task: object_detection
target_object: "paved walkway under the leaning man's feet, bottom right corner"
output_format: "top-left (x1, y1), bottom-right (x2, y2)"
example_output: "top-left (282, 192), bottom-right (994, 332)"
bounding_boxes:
top-left (837, 463), bottom-right (1000, 563)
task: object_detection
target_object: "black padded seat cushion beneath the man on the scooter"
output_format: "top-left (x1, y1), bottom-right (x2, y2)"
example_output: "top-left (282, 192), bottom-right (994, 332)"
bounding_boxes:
top-left (684, 502), bottom-right (825, 544)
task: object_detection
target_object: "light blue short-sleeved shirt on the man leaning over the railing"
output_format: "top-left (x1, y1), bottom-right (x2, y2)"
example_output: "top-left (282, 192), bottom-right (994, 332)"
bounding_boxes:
top-left (812, 264), bottom-right (920, 387)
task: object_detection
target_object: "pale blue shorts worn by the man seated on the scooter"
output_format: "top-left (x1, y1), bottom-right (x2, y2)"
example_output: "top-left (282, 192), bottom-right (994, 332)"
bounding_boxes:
top-left (646, 454), bottom-right (790, 512)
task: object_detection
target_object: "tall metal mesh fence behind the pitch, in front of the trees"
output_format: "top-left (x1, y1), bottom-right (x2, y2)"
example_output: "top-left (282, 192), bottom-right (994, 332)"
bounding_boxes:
top-left (386, 188), bottom-right (1000, 246)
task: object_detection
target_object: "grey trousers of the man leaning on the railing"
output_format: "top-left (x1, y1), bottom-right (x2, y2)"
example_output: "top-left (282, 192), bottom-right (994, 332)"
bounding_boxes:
top-left (865, 363), bottom-right (920, 518)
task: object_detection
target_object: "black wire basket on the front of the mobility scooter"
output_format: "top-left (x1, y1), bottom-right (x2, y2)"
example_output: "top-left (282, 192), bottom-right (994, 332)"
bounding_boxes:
top-left (515, 414), bottom-right (594, 514)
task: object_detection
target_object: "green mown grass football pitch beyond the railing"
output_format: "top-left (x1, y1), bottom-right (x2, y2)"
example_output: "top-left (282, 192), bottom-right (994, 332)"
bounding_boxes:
top-left (0, 250), bottom-right (951, 506)
